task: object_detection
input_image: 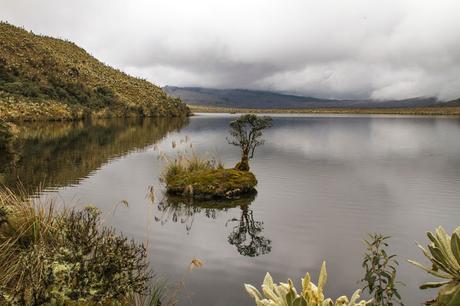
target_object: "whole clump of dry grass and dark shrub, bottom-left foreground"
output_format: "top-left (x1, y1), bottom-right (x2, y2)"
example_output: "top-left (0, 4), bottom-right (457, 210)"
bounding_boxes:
top-left (0, 191), bottom-right (152, 305)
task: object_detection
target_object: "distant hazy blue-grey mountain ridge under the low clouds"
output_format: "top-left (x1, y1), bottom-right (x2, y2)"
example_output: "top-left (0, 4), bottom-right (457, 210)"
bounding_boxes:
top-left (163, 86), bottom-right (460, 109)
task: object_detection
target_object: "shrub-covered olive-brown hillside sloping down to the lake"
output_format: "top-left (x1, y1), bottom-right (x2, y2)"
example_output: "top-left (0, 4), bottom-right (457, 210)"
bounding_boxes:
top-left (0, 22), bottom-right (189, 120)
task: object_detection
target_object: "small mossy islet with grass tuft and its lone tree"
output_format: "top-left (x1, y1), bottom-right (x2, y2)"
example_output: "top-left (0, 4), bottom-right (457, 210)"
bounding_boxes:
top-left (161, 114), bottom-right (272, 200)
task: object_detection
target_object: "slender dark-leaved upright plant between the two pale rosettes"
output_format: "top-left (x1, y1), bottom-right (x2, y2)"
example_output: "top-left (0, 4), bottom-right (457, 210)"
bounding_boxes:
top-left (361, 234), bottom-right (404, 306)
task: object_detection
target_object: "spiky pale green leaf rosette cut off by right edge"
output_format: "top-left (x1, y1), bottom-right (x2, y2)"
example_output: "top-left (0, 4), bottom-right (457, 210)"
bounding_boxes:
top-left (409, 227), bottom-right (460, 306)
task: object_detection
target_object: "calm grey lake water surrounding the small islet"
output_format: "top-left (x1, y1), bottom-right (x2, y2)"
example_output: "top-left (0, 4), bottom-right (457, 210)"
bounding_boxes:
top-left (0, 114), bottom-right (460, 305)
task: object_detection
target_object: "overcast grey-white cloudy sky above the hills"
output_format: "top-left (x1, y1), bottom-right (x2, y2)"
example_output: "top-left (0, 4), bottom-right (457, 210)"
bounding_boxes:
top-left (0, 0), bottom-right (460, 100)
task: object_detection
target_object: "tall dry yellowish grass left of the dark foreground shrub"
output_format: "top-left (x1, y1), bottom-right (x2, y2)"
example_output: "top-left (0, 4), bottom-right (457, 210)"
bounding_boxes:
top-left (0, 189), bottom-right (66, 302)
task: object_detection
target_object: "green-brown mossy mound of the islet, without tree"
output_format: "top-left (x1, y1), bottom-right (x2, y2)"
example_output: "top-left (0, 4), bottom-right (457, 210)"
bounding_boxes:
top-left (166, 169), bottom-right (257, 199)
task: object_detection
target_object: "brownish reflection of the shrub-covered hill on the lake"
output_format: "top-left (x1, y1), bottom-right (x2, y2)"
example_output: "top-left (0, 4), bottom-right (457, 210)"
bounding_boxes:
top-left (0, 118), bottom-right (187, 190)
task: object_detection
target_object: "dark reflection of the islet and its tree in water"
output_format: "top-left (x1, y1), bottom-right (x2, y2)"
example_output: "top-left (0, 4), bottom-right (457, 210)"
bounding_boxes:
top-left (155, 195), bottom-right (271, 257)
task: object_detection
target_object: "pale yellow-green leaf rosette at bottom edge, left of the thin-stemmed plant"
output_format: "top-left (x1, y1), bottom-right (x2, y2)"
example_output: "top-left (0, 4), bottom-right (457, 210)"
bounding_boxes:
top-left (244, 262), bottom-right (371, 306)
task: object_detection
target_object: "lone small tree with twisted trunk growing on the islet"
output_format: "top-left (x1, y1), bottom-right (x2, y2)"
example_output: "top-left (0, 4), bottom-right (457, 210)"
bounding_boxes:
top-left (227, 114), bottom-right (272, 171)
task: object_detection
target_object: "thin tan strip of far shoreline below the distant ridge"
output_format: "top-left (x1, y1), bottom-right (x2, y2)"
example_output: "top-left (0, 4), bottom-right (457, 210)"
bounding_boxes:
top-left (187, 104), bottom-right (460, 117)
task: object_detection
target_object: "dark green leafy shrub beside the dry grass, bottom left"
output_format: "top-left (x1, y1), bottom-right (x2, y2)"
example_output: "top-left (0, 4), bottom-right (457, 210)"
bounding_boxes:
top-left (49, 207), bottom-right (152, 302)
